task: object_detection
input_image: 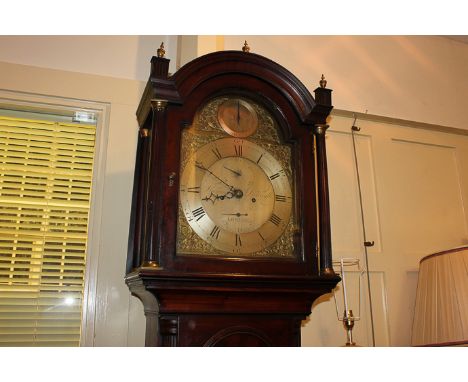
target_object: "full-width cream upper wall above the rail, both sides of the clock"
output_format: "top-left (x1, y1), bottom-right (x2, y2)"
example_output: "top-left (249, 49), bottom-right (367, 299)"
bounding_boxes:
top-left (0, 35), bottom-right (468, 129)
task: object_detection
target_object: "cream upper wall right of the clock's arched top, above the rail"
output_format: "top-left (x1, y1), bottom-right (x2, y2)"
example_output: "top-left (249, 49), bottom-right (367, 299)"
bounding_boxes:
top-left (224, 36), bottom-right (468, 129)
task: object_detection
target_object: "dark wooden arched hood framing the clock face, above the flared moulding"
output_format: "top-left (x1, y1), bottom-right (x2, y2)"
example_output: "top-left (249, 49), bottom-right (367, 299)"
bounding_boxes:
top-left (127, 51), bottom-right (332, 278)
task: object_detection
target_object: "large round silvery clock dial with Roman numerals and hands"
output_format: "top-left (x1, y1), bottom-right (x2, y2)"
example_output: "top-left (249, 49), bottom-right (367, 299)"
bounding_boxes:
top-left (180, 138), bottom-right (292, 254)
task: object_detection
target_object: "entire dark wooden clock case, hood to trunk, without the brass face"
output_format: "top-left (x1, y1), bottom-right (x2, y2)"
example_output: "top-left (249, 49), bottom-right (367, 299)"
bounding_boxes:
top-left (125, 51), bottom-right (339, 346)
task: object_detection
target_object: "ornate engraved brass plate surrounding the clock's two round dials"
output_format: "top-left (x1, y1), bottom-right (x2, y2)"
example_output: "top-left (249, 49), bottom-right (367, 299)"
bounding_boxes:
top-left (176, 96), bottom-right (299, 259)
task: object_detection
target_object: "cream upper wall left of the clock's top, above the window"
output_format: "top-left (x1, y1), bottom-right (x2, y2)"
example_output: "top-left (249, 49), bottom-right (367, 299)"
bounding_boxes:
top-left (0, 36), bottom-right (177, 81)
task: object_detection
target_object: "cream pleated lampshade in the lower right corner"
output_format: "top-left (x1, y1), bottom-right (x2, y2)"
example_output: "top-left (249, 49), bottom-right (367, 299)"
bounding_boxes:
top-left (411, 246), bottom-right (468, 346)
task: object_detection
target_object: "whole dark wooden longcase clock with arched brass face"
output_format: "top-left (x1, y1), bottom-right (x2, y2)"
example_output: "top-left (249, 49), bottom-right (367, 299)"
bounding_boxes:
top-left (126, 44), bottom-right (339, 346)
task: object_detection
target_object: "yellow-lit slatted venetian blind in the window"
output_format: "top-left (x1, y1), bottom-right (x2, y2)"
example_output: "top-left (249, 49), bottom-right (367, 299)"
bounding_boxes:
top-left (0, 114), bottom-right (96, 346)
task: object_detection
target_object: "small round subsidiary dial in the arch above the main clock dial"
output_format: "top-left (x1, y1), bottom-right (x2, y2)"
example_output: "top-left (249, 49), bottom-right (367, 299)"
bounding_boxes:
top-left (218, 98), bottom-right (258, 138)
